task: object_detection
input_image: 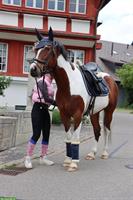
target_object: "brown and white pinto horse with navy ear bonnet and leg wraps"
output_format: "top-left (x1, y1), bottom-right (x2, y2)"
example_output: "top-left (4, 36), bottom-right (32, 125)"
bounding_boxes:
top-left (30, 28), bottom-right (118, 171)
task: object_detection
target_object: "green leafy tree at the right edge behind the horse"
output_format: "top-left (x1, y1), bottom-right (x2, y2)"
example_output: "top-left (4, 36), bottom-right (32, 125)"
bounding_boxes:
top-left (116, 62), bottom-right (133, 105)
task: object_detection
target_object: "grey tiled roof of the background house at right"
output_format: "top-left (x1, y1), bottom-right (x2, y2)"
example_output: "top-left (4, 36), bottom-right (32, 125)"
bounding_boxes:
top-left (96, 40), bottom-right (133, 81)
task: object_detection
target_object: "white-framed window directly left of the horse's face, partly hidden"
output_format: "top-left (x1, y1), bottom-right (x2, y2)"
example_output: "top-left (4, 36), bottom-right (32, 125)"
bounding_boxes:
top-left (23, 45), bottom-right (34, 73)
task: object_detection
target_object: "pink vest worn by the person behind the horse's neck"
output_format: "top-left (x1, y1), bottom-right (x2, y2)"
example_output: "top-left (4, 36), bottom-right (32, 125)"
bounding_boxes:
top-left (32, 74), bottom-right (54, 105)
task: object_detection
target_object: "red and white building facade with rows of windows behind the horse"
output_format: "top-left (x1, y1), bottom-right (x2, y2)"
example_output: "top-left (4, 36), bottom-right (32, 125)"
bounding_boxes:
top-left (0, 0), bottom-right (110, 106)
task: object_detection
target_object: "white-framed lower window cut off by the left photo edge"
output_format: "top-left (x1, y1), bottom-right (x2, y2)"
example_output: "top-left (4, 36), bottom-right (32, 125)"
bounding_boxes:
top-left (0, 43), bottom-right (8, 72)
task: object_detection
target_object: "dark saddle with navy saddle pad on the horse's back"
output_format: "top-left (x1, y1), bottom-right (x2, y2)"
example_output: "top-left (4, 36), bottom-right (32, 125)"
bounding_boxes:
top-left (80, 62), bottom-right (109, 97)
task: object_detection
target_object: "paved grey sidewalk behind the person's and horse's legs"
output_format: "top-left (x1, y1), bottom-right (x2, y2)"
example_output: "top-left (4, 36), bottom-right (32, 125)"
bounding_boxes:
top-left (0, 125), bottom-right (93, 168)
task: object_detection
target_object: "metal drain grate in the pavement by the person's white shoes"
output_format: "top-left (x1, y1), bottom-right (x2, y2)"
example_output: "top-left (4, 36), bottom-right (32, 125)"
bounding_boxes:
top-left (0, 167), bottom-right (30, 176)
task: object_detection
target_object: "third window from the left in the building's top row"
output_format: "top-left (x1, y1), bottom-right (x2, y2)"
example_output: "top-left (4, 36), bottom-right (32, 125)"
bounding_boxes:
top-left (48, 0), bottom-right (65, 11)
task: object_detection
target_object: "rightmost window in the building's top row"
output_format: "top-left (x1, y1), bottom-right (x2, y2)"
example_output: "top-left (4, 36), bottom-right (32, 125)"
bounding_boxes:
top-left (69, 0), bottom-right (86, 14)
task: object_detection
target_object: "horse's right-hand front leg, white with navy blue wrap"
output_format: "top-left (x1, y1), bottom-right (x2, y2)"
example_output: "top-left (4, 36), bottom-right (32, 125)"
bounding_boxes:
top-left (68, 122), bottom-right (82, 172)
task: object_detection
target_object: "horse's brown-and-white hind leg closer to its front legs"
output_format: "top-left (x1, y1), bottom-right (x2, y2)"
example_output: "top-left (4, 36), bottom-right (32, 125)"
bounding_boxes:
top-left (85, 113), bottom-right (101, 160)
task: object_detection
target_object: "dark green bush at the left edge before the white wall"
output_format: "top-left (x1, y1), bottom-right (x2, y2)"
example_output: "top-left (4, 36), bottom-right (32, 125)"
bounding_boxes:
top-left (0, 76), bottom-right (11, 96)
